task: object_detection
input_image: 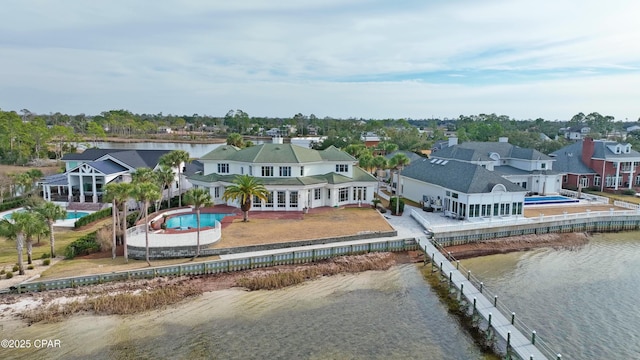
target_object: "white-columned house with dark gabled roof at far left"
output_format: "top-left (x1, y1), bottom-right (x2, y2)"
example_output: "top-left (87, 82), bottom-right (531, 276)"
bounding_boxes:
top-left (42, 149), bottom-right (188, 204)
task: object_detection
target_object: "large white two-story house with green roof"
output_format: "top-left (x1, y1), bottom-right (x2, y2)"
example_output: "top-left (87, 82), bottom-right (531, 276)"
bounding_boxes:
top-left (188, 139), bottom-right (377, 211)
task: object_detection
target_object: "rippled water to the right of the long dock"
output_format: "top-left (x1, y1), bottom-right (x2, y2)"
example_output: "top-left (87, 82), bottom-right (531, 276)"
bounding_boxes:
top-left (462, 232), bottom-right (640, 359)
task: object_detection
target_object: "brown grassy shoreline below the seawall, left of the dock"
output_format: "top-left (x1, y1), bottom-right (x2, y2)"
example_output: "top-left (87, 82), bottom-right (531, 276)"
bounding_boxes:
top-left (0, 251), bottom-right (421, 325)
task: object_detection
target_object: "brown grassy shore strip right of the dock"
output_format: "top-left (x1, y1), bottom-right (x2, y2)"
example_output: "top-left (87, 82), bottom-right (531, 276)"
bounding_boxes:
top-left (445, 233), bottom-right (589, 259)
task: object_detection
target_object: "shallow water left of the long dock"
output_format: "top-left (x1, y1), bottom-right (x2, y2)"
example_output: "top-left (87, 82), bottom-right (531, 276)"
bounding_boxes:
top-left (0, 264), bottom-right (490, 359)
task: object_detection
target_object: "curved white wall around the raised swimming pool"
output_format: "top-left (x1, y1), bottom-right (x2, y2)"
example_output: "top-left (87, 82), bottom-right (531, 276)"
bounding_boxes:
top-left (127, 221), bottom-right (222, 248)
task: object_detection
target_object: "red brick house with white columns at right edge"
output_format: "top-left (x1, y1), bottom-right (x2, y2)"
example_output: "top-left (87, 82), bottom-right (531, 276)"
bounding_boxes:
top-left (551, 137), bottom-right (640, 191)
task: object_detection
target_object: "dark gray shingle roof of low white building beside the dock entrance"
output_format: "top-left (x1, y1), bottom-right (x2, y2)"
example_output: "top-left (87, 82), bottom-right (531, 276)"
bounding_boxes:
top-left (401, 159), bottom-right (526, 194)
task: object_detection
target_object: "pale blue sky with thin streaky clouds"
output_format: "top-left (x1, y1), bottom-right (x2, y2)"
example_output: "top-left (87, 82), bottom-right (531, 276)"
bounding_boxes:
top-left (0, 0), bottom-right (640, 121)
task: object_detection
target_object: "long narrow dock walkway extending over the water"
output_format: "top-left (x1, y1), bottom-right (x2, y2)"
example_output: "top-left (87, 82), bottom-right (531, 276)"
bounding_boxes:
top-left (416, 236), bottom-right (549, 360)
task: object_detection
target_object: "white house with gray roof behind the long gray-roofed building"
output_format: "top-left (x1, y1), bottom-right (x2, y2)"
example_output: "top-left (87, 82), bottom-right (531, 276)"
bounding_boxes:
top-left (431, 137), bottom-right (565, 195)
